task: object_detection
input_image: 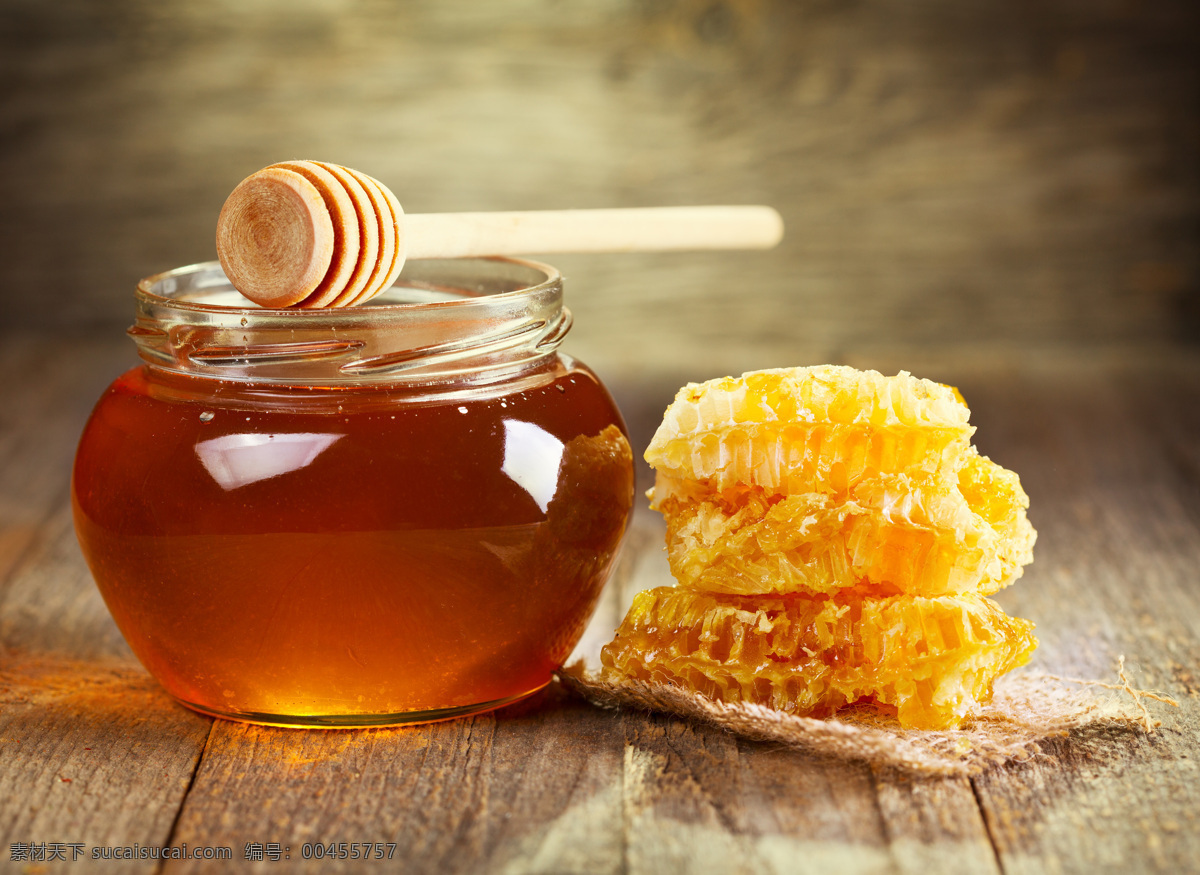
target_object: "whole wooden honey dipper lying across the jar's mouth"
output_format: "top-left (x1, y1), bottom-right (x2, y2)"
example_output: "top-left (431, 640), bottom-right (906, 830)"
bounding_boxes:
top-left (217, 161), bottom-right (784, 307)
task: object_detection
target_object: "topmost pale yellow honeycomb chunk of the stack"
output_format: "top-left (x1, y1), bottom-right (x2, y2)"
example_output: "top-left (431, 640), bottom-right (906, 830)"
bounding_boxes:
top-left (646, 365), bottom-right (974, 493)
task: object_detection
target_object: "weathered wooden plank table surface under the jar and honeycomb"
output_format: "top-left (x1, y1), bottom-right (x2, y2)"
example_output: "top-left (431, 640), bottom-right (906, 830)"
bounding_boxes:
top-left (0, 334), bottom-right (1200, 875)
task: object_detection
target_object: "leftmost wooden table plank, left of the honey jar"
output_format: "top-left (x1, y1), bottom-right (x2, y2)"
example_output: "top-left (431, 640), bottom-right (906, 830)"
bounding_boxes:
top-left (0, 336), bottom-right (210, 873)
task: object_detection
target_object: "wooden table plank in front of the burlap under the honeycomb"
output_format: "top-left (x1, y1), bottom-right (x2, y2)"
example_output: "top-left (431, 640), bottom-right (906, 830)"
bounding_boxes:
top-left (622, 713), bottom-right (998, 874)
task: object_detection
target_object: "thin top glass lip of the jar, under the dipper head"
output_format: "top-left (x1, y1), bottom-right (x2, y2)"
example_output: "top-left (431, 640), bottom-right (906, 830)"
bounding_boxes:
top-left (134, 256), bottom-right (563, 322)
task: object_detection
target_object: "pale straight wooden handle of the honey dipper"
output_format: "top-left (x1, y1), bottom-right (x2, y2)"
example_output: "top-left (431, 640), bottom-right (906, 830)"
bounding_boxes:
top-left (404, 206), bottom-right (784, 258)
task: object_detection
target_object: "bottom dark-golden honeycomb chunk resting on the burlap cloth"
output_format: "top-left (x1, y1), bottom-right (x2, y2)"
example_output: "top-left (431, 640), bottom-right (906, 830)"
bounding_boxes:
top-left (602, 587), bottom-right (1036, 729)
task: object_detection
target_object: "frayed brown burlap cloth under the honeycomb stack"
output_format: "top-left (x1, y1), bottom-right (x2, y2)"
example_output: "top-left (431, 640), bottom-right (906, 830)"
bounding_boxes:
top-left (558, 658), bottom-right (1176, 777)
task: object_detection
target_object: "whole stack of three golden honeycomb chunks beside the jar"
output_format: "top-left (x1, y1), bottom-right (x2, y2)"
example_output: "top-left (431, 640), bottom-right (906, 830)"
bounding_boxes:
top-left (602, 366), bottom-right (1037, 729)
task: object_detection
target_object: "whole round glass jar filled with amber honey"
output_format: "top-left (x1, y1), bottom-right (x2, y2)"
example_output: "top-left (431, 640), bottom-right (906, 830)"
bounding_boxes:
top-left (72, 258), bottom-right (634, 726)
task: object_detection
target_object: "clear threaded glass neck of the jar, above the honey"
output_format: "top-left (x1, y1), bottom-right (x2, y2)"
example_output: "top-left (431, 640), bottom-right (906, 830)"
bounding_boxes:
top-left (128, 256), bottom-right (571, 385)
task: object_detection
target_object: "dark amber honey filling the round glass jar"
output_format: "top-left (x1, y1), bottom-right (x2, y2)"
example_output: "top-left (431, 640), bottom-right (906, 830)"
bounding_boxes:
top-left (73, 254), bottom-right (632, 725)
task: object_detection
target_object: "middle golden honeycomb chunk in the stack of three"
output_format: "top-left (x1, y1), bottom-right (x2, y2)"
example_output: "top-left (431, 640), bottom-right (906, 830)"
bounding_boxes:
top-left (654, 448), bottom-right (1036, 595)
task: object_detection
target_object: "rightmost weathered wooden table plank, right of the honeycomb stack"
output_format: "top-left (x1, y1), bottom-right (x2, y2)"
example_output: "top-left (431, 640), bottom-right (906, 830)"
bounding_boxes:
top-left (960, 371), bottom-right (1200, 873)
